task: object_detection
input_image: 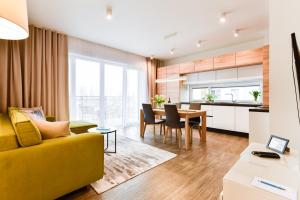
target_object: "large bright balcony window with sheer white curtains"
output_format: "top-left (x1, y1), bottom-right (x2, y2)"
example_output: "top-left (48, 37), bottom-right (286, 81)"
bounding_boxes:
top-left (69, 54), bottom-right (146, 127)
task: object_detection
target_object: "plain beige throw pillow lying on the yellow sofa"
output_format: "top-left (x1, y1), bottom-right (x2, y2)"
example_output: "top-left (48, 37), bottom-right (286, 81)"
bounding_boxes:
top-left (32, 118), bottom-right (70, 140)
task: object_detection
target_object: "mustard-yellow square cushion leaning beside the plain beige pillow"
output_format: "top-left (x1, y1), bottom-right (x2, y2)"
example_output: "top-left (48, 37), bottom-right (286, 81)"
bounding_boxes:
top-left (9, 109), bottom-right (42, 147)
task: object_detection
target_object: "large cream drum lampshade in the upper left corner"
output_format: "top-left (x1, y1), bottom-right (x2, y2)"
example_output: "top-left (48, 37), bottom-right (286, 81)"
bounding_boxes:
top-left (0, 0), bottom-right (29, 40)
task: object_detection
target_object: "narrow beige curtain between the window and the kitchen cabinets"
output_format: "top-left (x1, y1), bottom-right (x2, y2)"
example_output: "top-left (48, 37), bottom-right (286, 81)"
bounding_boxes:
top-left (146, 58), bottom-right (160, 103)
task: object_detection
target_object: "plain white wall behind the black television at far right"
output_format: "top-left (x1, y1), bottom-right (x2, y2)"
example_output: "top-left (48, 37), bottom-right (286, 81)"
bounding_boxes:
top-left (269, 0), bottom-right (300, 150)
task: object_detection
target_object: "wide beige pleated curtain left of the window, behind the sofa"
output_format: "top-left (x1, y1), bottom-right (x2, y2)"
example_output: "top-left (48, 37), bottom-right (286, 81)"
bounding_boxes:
top-left (0, 26), bottom-right (69, 120)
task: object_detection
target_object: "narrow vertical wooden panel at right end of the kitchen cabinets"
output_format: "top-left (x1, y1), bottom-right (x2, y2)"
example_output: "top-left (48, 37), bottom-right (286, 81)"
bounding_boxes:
top-left (263, 45), bottom-right (270, 106)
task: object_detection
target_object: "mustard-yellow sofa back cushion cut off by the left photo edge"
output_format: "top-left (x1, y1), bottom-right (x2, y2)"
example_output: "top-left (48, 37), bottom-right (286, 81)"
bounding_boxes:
top-left (0, 113), bottom-right (19, 152)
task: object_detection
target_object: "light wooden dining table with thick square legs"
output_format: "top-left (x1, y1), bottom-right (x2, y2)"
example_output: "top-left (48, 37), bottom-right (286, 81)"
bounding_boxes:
top-left (140, 108), bottom-right (206, 150)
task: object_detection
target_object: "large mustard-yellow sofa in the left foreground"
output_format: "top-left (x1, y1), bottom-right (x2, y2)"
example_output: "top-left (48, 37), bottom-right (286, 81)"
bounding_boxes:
top-left (0, 113), bottom-right (104, 200)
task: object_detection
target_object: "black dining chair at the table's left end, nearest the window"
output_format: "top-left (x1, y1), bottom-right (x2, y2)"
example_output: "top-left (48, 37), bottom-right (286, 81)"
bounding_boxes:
top-left (142, 104), bottom-right (166, 136)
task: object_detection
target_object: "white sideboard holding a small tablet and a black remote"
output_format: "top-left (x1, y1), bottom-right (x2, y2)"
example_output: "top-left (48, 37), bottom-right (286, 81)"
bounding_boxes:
top-left (222, 143), bottom-right (300, 200)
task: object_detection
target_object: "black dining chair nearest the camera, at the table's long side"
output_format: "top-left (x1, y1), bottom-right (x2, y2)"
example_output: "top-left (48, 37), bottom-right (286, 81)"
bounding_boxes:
top-left (163, 104), bottom-right (185, 148)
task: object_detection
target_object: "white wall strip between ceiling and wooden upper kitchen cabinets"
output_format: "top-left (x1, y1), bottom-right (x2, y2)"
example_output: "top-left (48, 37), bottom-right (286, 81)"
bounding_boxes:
top-left (164, 37), bottom-right (268, 65)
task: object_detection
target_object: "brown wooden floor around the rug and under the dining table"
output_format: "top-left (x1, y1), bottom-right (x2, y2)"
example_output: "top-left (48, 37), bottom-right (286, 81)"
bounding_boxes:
top-left (60, 127), bottom-right (248, 200)
